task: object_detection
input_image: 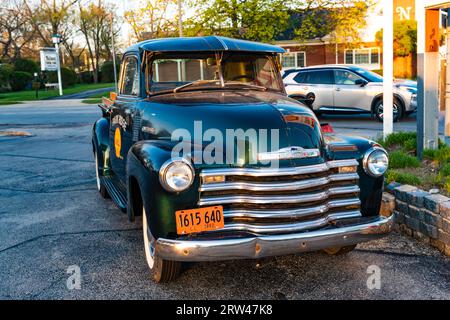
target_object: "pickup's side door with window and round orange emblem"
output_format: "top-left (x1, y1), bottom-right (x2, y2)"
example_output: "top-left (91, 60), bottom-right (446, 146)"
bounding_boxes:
top-left (109, 56), bottom-right (139, 183)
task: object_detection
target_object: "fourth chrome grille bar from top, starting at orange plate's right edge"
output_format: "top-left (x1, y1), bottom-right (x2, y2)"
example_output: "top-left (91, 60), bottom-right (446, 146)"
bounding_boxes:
top-left (223, 198), bottom-right (361, 219)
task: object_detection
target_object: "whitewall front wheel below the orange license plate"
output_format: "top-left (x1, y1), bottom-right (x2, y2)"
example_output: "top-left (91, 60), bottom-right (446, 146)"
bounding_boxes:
top-left (142, 207), bottom-right (181, 283)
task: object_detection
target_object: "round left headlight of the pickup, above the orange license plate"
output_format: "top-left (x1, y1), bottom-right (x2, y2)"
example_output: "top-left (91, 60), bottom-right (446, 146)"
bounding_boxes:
top-left (159, 158), bottom-right (195, 192)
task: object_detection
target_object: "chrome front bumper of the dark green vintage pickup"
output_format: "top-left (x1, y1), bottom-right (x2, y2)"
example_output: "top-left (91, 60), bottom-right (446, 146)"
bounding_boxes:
top-left (156, 216), bottom-right (394, 261)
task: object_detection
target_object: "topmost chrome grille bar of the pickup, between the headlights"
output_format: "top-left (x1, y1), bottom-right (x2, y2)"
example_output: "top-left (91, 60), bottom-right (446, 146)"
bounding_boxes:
top-left (200, 159), bottom-right (358, 178)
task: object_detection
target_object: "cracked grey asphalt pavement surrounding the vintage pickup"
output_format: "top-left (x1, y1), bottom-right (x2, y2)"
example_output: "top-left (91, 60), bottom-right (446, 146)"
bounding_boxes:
top-left (0, 100), bottom-right (450, 300)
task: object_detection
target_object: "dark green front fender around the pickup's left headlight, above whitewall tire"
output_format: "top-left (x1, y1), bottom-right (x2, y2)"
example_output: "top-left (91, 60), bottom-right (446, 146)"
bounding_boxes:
top-left (127, 140), bottom-right (199, 238)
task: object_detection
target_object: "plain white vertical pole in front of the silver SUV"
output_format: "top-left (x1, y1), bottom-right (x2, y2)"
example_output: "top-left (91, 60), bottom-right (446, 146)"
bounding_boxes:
top-left (383, 0), bottom-right (394, 138)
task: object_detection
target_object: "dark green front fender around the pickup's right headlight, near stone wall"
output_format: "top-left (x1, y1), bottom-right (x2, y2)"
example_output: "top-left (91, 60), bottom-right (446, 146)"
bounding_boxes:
top-left (325, 135), bottom-right (384, 217)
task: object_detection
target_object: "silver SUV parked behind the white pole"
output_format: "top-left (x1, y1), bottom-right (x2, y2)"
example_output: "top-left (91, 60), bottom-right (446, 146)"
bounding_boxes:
top-left (283, 65), bottom-right (417, 121)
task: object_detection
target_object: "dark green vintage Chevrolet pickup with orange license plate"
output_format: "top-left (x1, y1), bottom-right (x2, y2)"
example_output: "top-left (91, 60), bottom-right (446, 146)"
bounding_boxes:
top-left (92, 36), bottom-right (393, 282)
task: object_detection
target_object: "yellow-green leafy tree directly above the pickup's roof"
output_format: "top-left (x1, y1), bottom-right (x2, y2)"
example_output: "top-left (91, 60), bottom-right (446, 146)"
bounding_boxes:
top-left (186, 0), bottom-right (289, 42)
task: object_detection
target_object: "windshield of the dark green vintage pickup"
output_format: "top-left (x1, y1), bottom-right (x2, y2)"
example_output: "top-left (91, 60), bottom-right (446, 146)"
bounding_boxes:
top-left (149, 52), bottom-right (281, 94)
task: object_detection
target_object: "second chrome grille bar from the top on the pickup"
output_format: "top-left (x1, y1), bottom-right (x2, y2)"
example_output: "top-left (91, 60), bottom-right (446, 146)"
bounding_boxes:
top-left (199, 173), bottom-right (359, 192)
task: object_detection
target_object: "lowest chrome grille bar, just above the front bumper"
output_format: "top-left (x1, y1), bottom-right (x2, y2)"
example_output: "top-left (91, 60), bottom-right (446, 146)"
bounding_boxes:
top-left (208, 211), bottom-right (361, 234)
